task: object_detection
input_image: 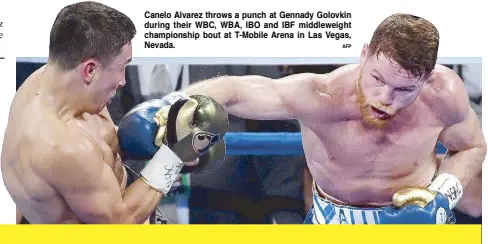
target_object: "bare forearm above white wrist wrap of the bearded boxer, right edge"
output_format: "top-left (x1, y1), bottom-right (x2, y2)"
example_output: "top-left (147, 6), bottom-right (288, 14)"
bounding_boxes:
top-left (439, 144), bottom-right (486, 188)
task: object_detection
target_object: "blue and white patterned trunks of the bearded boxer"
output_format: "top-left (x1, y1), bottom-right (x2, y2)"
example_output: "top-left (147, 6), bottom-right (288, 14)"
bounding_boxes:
top-left (304, 181), bottom-right (383, 224)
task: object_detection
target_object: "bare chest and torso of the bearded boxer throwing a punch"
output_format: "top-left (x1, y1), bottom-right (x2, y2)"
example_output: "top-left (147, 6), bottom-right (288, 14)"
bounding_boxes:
top-left (302, 99), bottom-right (442, 205)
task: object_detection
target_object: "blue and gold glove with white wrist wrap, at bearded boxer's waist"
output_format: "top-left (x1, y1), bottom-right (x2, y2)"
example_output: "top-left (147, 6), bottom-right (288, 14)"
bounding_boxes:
top-left (379, 173), bottom-right (463, 224)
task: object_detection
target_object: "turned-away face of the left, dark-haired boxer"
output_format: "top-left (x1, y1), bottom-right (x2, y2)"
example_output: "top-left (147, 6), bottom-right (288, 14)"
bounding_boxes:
top-left (82, 43), bottom-right (132, 110)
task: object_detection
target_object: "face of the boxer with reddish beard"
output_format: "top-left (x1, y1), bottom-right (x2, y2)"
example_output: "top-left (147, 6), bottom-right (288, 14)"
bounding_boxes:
top-left (356, 46), bottom-right (425, 128)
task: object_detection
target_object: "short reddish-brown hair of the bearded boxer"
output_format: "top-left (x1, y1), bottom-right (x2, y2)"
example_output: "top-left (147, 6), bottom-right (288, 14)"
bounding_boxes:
top-left (369, 14), bottom-right (439, 78)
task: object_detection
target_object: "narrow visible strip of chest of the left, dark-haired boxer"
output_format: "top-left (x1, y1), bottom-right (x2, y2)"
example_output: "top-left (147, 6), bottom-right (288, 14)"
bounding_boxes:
top-left (78, 113), bottom-right (126, 188)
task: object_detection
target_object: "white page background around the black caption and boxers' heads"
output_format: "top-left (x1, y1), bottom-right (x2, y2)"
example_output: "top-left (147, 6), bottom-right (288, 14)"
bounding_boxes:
top-left (0, 0), bottom-right (487, 234)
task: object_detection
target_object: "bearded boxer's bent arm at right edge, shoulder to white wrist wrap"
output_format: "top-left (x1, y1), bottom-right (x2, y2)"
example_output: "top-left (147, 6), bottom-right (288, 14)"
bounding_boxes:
top-left (439, 76), bottom-right (486, 188)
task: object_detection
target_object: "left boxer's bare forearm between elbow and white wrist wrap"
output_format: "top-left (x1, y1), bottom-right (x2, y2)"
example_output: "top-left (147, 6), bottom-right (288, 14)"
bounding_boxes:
top-left (121, 179), bottom-right (162, 224)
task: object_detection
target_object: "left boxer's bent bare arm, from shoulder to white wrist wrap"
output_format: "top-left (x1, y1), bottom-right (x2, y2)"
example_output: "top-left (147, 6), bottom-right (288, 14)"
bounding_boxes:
top-left (42, 131), bottom-right (162, 224)
